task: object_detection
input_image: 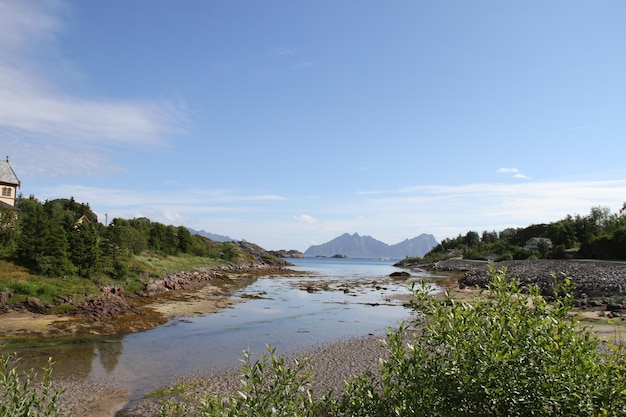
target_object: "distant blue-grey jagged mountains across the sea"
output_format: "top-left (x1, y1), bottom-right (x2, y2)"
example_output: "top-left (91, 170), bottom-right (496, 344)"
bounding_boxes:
top-left (304, 233), bottom-right (438, 258)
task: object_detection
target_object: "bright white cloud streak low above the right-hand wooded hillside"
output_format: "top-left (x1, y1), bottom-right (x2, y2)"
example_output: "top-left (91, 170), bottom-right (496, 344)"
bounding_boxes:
top-left (354, 180), bottom-right (626, 232)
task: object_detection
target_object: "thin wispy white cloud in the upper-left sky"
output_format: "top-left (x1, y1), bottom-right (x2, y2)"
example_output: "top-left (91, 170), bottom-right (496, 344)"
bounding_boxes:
top-left (0, 0), bottom-right (185, 173)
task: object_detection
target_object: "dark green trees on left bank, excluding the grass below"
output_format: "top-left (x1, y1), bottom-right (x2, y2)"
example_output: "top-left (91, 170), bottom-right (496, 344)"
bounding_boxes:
top-left (0, 196), bottom-right (239, 280)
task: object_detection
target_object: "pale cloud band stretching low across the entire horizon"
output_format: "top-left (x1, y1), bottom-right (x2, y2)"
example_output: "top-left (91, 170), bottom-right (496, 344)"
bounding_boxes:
top-left (30, 180), bottom-right (626, 250)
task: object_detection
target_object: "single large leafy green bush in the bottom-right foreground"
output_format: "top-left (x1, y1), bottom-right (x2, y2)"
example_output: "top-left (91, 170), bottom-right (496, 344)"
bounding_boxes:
top-left (343, 271), bottom-right (626, 416)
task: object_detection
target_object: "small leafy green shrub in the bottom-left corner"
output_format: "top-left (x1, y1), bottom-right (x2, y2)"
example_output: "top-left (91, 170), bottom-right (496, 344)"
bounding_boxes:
top-left (0, 354), bottom-right (62, 417)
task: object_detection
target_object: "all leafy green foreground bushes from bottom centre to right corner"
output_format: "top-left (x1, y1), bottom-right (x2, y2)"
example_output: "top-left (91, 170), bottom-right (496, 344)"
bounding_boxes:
top-left (161, 270), bottom-right (626, 417)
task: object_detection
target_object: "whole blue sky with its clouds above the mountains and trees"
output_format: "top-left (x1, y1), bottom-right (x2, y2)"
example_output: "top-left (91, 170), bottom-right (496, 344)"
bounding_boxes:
top-left (0, 0), bottom-right (626, 250)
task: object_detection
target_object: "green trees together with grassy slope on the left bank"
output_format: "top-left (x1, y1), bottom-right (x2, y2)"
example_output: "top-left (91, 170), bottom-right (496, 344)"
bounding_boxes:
top-left (0, 196), bottom-right (251, 304)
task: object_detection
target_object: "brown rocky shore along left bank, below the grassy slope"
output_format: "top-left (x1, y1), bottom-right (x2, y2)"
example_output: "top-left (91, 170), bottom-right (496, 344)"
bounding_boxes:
top-left (0, 263), bottom-right (289, 337)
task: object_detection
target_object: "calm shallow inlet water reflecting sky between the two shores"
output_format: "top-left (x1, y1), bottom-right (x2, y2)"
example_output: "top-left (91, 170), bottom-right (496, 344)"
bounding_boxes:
top-left (9, 258), bottom-right (438, 399)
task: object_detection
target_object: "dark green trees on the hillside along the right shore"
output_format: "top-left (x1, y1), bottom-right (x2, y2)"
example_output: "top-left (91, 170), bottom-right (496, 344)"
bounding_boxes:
top-left (424, 203), bottom-right (626, 261)
